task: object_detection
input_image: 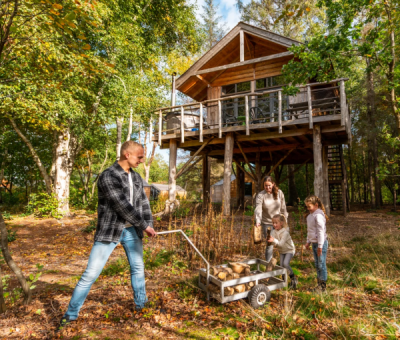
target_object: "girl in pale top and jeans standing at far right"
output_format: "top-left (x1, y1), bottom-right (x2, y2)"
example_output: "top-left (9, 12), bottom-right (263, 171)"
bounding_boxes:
top-left (304, 195), bottom-right (328, 292)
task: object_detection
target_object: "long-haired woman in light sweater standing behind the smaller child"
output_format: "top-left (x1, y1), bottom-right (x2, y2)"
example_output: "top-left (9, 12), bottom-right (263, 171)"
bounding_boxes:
top-left (254, 176), bottom-right (288, 258)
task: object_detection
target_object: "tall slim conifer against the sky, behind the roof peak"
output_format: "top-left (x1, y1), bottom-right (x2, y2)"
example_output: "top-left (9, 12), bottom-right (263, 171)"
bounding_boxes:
top-left (201, 0), bottom-right (226, 51)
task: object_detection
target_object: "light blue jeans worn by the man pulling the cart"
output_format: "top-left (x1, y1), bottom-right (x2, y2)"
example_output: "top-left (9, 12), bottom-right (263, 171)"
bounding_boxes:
top-left (64, 227), bottom-right (147, 320)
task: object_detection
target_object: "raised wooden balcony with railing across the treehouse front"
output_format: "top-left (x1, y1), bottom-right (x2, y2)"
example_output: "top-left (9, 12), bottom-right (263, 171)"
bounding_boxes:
top-left (152, 79), bottom-right (351, 147)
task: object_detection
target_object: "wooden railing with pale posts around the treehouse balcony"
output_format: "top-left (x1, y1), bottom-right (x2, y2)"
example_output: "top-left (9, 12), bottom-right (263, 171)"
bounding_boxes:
top-left (154, 78), bottom-right (349, 145)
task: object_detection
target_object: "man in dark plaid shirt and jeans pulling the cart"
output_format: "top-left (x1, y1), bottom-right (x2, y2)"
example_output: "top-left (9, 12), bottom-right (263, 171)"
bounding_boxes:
top-left (60, 141), bottom-right (157, 327)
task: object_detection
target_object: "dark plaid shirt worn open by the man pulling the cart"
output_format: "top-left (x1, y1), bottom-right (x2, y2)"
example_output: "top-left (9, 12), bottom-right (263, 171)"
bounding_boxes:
top-left (94, 162), bottom-right (153, 242)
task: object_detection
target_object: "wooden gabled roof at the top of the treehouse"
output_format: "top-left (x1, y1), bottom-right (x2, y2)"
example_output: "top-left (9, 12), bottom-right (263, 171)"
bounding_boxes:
top-left (176, 22), bottom-right (300, 99)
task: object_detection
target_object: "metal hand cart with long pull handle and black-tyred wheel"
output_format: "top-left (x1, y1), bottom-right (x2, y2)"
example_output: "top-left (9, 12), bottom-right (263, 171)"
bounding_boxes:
top-left (157, 230), bottom-right (287, 309)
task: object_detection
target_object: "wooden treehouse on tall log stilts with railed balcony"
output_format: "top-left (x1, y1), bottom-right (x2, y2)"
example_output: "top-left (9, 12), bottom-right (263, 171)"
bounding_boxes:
top-left (153, 22), bottom-right (351, 215)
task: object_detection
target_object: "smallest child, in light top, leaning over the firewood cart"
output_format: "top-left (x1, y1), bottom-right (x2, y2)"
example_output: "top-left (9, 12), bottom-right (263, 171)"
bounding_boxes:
top-left (265, 214), bottom-right (298, 289)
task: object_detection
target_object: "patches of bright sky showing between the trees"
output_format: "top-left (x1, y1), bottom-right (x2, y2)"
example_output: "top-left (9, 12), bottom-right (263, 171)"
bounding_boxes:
top-left (156, 0), bottom-right (250, 163)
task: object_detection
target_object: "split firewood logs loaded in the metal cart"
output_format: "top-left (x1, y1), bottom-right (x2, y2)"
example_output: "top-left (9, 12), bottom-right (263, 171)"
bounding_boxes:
top-left (201, 259), bottom-right (277, 296)
